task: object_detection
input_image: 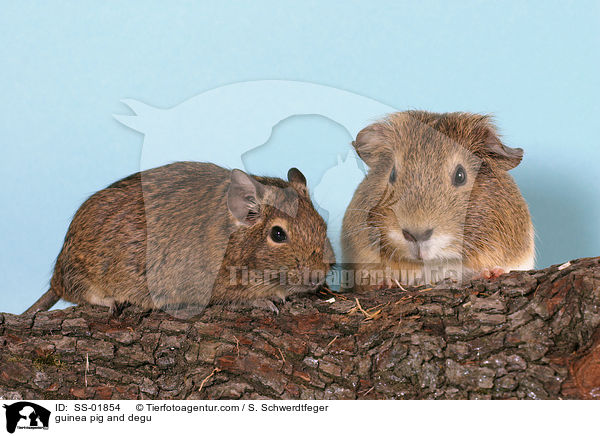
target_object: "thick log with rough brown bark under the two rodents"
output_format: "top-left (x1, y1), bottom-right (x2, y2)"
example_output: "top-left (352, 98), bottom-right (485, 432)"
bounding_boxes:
top-left (0, 258), bottom-right (600, 399)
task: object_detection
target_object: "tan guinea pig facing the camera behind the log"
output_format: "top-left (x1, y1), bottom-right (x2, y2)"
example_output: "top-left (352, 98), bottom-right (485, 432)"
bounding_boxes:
top-left (342, 111), bottom-right (535, 290)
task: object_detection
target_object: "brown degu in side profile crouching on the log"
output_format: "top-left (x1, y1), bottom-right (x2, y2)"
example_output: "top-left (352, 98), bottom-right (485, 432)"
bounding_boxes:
top-left (26, 162), bottom-right (335, 316)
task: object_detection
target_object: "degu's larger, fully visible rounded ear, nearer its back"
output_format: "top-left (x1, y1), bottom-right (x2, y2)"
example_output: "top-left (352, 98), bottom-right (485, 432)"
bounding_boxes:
top-left (227, 170), bottom-right (262, 226)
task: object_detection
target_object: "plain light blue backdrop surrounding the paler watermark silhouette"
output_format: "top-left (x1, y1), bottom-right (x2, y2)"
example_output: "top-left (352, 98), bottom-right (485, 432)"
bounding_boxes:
top-left (0, 1), bottom-right (600, 312)
